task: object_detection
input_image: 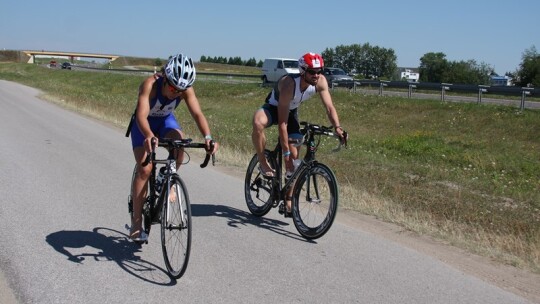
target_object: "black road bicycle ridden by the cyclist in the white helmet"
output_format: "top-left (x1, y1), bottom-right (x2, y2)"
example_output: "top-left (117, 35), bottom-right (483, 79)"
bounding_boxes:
top-left (127, 138), bottom-right (215, 278)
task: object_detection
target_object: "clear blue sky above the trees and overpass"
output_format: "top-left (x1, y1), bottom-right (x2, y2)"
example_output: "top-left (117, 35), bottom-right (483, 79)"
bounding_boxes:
top-left (0, 0), bottom-right (540, 74)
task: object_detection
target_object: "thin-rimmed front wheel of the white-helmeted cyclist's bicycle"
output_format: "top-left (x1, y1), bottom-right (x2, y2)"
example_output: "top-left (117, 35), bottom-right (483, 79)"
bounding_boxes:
top-left (161, 174), bottom-right (191, 279)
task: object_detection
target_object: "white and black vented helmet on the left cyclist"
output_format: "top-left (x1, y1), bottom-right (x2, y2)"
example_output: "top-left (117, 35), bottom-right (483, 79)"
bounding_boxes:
top-left (165, 54), bottom-right (197, 90)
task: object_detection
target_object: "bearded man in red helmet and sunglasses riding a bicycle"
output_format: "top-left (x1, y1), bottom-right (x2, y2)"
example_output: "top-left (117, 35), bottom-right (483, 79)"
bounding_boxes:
top-left (251, 53), bottom-right (343, 213)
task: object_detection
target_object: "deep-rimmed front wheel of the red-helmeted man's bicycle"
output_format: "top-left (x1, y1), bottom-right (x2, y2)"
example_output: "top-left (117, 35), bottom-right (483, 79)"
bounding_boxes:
top-left (292, 163), bottom-right (339, 239)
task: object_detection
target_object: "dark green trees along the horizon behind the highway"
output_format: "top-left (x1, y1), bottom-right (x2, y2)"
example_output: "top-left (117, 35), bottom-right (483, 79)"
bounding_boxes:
top-left (200, 43), bottom-right (540, 87)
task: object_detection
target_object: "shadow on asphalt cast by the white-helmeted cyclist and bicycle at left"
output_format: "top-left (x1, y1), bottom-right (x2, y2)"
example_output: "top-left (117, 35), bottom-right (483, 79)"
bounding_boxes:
top-left (45, 227), bottom-right (176, 286)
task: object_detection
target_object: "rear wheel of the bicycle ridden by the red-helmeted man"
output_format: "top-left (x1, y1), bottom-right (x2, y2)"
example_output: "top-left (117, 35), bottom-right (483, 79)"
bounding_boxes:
top-left (244, 150), bottom-right (277, 216)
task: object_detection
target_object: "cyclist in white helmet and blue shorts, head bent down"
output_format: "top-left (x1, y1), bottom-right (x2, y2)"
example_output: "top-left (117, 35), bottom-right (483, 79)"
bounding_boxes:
top-left (128, 54), bottom-right (218, 241)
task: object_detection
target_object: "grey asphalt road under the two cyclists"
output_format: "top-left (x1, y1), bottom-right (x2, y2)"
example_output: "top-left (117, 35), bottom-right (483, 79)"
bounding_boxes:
top-left (0, 80), bottom-right (527, 304)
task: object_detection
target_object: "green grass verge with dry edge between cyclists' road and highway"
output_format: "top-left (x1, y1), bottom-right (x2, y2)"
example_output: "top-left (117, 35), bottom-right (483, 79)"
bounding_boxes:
top-left (0, 63), bottom-right (540, 273)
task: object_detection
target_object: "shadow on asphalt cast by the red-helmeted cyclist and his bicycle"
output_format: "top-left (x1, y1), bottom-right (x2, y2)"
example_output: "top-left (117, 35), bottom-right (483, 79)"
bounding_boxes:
top-left (191, 204), bottom-right (317, 244)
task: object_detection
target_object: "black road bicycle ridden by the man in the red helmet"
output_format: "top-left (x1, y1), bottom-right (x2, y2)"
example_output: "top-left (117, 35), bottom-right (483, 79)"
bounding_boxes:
top-left (244, 122), bottom-right (347, 239)
